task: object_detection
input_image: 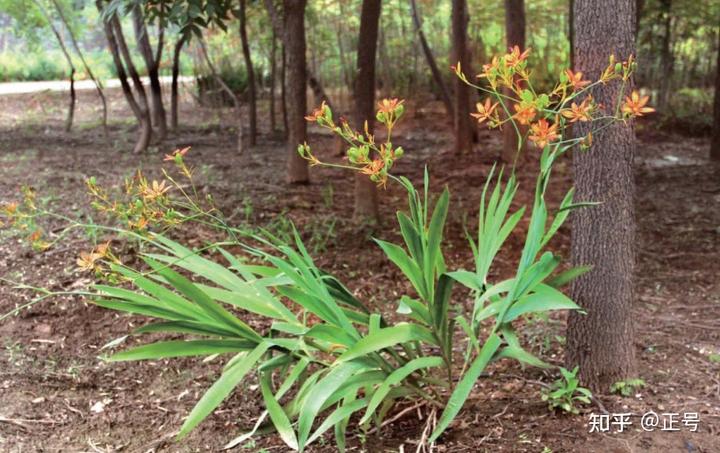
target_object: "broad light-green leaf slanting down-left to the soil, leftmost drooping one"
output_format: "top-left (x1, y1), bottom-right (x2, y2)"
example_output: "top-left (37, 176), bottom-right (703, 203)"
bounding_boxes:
top-left (177, 343), bottom-right (269, 439)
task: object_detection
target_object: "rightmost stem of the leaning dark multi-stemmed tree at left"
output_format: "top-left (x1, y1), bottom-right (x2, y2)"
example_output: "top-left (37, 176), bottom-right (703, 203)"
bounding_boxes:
top-left (132, 6), bottom-right (167, 142)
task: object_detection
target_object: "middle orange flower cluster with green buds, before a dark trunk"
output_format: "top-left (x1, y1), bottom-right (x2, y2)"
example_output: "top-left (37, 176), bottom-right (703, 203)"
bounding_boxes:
top-left (298, 99), bottom-right (405, 187)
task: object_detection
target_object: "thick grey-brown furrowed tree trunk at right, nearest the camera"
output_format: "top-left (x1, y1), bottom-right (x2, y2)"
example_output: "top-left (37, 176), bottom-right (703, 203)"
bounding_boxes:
top-left (566, 0), bottom-right (635, 391)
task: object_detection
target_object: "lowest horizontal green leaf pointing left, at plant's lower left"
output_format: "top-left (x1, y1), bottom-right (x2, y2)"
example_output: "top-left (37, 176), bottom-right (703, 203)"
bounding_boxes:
top-left (108, 340), bottom-right (257, 362)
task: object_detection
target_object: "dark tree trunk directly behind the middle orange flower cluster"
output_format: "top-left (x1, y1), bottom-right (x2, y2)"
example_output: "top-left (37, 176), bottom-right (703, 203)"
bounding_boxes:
top-left (353, 0), bottom-right (382, 222)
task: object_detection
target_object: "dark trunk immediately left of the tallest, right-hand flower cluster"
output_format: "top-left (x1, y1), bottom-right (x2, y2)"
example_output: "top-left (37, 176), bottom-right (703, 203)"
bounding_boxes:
top-left (452, 0), bottom-right (472, 154)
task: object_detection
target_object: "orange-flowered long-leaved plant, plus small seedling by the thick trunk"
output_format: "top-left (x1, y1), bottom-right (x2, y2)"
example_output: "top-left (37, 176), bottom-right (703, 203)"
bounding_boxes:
top-left (4, 48), bottom-right (651, 451)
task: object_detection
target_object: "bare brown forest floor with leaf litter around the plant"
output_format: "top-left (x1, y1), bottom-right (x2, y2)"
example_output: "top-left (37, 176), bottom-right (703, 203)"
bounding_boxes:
top-left (0, 86), bottom-right (720, 453)
